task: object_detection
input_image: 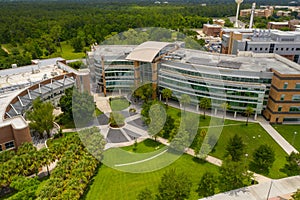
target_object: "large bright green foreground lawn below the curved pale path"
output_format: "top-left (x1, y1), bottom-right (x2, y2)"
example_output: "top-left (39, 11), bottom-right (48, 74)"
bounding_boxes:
top-left (83, 140), bottom-right (218, 200)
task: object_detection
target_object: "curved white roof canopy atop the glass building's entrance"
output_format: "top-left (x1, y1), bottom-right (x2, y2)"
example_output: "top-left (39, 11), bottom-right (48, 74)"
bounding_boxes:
top-left (126, 41), bottom-right (175, 62)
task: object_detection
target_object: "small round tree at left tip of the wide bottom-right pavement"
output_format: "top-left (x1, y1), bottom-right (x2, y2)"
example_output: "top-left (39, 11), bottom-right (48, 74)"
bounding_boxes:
top-left (196, 172), bottom-right (218, 197)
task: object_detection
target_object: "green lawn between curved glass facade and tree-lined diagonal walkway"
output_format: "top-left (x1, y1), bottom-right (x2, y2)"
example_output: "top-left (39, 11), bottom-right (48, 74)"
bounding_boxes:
top-left (167, 107), bottom-right (288, 179)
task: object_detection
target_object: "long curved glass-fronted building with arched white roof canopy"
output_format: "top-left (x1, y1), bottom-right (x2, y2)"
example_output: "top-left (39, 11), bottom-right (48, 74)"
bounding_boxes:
top-left (89, 42), bottom-right (300, 123)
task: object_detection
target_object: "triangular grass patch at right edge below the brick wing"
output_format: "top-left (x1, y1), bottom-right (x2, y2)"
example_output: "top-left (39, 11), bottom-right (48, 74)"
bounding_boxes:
top-left (273, 124), bottom-right (300, 151)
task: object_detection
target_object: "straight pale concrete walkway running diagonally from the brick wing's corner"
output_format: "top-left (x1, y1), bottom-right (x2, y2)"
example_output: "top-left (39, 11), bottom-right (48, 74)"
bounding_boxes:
top-left (258, 117), bottom-right (298, 154)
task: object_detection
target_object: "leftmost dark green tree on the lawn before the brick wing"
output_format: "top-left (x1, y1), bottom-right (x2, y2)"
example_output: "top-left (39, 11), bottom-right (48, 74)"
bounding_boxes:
top-left (226, 134), bottom-right (246, 162)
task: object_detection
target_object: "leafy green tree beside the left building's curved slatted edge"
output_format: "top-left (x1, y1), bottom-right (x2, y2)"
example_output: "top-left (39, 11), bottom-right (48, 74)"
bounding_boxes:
top-left (26, 98), bottom-right (54, 138)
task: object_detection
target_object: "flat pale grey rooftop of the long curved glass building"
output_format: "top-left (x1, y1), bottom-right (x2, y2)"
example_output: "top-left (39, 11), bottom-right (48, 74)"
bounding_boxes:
top-left (90, 42), bottom-right (300, 74)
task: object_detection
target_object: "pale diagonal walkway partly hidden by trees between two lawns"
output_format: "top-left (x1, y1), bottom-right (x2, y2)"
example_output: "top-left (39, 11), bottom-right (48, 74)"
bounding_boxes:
top-left (156, 137), bottom-right (272, 183)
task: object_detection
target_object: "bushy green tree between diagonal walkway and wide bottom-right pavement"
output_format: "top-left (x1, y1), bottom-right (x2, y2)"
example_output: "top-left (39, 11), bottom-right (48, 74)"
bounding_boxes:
top-left (219, 157), bottom-right (253, 192)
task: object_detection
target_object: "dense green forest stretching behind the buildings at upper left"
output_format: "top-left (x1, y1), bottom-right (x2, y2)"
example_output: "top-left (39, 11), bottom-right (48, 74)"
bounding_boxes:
top-left (0, 1), bottom-right (235, 69)
